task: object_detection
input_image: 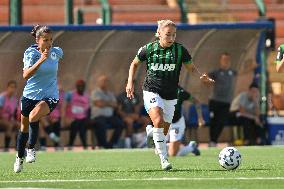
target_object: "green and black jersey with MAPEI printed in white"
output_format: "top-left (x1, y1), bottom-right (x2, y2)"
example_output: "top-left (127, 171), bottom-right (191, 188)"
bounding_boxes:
top-left (137, 40), bottom-right (191, 100)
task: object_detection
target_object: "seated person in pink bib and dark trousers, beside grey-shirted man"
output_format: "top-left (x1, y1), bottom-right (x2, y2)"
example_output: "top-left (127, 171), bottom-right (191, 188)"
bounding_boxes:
top-left (62, 80), bottom-right (90, 149)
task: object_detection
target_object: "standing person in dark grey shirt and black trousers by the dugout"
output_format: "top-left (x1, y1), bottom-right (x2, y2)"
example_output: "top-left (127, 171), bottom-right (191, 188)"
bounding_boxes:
top-left (208, 52), bottom-right (237, 147)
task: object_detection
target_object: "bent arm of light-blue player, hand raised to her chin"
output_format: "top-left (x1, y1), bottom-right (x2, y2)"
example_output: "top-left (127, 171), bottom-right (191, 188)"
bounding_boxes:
top-left (23, 49), bottom-right (49, 80)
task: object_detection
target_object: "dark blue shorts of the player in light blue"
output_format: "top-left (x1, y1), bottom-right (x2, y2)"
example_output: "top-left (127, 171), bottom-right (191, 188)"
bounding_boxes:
top-left (21, 97), bottom-right (59, 117)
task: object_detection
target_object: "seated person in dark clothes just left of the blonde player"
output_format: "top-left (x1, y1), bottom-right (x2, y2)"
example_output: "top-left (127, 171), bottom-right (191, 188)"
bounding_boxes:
top-left (117, 80), bottom-right (148, 148)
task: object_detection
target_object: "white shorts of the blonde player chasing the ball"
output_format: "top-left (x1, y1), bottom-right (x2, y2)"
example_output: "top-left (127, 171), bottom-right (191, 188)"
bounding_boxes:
top-left (143, 91), bottom-right (177, 123)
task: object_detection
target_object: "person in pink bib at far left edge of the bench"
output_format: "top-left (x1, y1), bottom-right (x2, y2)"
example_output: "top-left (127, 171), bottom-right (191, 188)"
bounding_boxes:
top-left (0, 81), bottom-right (20, 151)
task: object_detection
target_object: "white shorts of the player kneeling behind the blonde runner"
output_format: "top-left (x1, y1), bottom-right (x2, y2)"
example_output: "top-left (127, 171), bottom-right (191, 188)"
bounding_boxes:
top-left (166, 116), bottom-right (185, 142)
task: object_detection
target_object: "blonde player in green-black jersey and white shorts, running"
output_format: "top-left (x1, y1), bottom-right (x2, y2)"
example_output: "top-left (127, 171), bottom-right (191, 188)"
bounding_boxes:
top-left (126, 20), bottom-right (214, 170)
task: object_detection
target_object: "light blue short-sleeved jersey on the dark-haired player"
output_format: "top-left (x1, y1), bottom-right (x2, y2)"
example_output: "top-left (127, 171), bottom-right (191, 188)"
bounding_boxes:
top-left (23, 45), bottom-right (63, 100)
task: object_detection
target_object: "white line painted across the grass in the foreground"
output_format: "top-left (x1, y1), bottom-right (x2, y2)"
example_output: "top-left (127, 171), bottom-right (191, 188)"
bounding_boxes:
top-left (0, 177), bottom-right (284, 183)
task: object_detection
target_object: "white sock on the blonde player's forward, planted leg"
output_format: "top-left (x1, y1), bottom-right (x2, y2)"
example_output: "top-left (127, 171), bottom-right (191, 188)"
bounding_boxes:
top-left (153, 128), bottom-right (168, 160)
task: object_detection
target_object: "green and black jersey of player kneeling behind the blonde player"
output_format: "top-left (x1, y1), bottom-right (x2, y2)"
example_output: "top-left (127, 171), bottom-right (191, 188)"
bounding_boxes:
top-left (172, 86), bottom-right (192, 123)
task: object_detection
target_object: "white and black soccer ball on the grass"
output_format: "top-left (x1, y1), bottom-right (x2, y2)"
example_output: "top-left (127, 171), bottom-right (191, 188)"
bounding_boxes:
top-left (219, 147), bottom-right (242, 170)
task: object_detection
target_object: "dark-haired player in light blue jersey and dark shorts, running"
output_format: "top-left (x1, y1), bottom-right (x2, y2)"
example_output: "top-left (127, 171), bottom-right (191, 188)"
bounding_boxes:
top-left (14, 25), bottom-right (63, 173)
